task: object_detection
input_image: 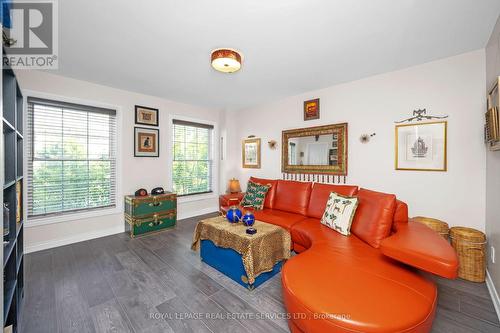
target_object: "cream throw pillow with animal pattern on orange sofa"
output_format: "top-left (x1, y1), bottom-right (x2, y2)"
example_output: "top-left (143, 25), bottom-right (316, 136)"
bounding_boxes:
top-left (321, 192), bottom-right (358, 236)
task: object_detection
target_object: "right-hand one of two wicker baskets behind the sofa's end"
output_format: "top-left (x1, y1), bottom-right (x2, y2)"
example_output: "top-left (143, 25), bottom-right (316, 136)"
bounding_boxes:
top-left (450, 227), bottom-right (486, 282)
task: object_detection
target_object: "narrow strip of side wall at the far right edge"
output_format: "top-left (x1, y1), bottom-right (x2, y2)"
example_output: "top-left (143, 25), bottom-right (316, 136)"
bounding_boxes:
top-left (481, 14), bottom-right (500, 310)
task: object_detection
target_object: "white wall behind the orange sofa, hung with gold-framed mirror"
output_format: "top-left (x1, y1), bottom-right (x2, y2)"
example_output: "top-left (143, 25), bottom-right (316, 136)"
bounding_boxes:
top-left (225, 50), bottom-right (485, 230)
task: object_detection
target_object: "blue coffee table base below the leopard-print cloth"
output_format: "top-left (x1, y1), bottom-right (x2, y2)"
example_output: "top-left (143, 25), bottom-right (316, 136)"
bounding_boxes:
top-left (200, 240), bottom-right (283, 290)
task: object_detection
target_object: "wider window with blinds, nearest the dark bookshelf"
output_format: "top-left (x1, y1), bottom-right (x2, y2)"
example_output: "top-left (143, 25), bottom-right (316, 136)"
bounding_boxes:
top-left (27, 97), bottom-right (116, 217)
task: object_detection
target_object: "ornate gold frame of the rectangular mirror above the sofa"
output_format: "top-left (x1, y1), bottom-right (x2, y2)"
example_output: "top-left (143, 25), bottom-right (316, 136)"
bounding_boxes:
top-left (281, 123), bottom-right (347, 176)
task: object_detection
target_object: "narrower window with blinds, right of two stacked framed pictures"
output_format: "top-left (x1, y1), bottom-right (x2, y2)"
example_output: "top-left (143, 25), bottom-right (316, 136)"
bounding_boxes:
top-left (172, 119), bottom-right (214, 196)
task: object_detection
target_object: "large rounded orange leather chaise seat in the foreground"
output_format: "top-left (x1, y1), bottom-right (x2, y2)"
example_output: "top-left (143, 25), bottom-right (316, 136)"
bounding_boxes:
top-left (281, 244), bottom-right (437, 333)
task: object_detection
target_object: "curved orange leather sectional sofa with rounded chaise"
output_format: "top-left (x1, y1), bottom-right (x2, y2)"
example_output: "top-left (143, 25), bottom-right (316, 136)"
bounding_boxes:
top-left (221, 177), bottom-right (458, 333)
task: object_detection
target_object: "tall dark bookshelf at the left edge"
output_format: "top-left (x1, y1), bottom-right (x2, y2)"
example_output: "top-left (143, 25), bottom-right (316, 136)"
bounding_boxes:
top-left (1, 64), bottom-right (24, 332)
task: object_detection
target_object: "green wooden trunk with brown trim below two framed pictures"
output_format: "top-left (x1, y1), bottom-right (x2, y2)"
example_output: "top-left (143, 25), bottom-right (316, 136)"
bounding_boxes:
top-left (125, 192), bottom-right (177, 237)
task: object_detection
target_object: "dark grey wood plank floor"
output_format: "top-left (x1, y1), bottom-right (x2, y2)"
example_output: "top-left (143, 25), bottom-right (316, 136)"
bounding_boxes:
top-left (20, 214), bottom-right (500, 333)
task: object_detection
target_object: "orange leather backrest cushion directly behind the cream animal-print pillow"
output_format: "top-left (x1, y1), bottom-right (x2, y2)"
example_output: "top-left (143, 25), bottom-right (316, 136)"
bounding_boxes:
top-left (307, 183), bottom-right (358, 219)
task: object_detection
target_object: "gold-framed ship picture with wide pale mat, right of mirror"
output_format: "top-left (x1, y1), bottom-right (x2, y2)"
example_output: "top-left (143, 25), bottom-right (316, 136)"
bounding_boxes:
top-left (396, 121), bottom-right (448, 171)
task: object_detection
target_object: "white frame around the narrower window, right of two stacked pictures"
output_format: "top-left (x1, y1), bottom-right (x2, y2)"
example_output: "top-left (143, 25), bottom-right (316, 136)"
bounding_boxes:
top-left (167, 114), bottom-right (219, 203)
